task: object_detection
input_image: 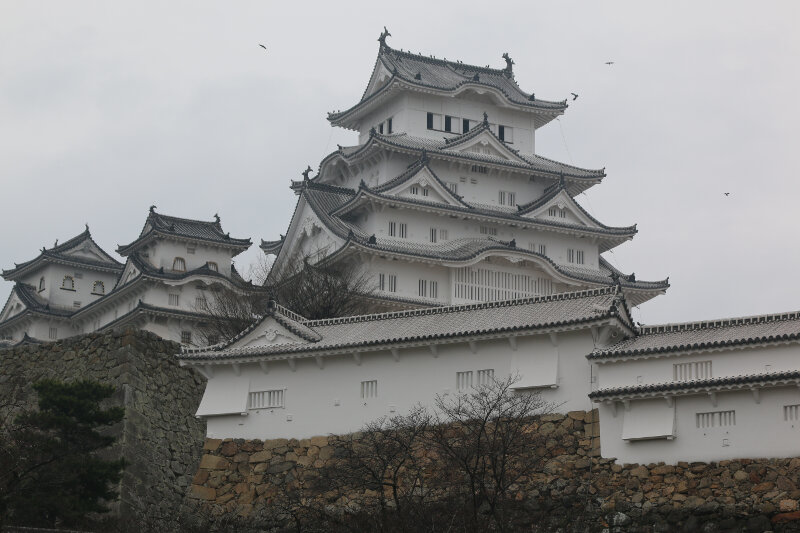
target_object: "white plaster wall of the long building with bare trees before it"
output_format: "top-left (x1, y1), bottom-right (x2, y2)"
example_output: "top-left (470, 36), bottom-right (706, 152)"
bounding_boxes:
top-left (198, 330), bottom-right (593, 439)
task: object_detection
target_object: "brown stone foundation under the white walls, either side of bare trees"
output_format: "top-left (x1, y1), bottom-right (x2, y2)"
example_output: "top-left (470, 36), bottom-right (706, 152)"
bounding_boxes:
top-left (190, 410), bottom-right (800, 532)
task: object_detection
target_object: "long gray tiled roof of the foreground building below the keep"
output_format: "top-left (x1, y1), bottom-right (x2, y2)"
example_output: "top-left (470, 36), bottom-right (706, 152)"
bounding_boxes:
top-left (179, 287), bottom-right (630, 361)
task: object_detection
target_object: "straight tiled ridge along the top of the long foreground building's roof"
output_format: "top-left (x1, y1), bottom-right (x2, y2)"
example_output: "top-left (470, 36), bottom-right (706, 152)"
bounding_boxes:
top-left (304, 286), bottom-right (616, 327)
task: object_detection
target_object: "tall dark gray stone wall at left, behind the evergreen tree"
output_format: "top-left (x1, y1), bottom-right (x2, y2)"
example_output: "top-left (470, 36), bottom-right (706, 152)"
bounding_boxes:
top-left (0, 329), bottom-right (206, 531)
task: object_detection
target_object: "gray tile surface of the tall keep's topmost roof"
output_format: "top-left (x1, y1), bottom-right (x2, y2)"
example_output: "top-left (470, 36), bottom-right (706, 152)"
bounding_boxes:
top-left (328, 44), bottom-right (567, 124)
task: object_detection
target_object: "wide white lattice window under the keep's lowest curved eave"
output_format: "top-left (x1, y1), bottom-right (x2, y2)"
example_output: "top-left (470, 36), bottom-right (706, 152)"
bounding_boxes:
top-left (454, 267), bottom-right (553, 302)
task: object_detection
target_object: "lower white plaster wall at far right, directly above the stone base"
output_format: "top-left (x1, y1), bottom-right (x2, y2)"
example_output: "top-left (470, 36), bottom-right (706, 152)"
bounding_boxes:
top-left (599, 386), bottom-right (800, 464)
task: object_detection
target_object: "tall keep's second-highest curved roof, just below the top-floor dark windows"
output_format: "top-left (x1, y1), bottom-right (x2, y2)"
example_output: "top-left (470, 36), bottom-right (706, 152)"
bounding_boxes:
top-left (313, 130), bottom-right (606, 195)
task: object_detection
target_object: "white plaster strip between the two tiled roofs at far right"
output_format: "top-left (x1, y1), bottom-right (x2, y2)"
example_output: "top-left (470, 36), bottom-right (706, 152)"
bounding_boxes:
top-left (597, 344), bottom-right (800, 388)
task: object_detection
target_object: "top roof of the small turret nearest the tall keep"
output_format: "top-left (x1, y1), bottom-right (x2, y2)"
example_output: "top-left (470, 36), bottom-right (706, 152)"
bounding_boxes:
top-left (117, 206), bottom-right (253, 256)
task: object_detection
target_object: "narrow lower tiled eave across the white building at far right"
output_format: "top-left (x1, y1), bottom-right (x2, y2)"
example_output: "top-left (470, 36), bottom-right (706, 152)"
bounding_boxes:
top-left (589, 370), bottom-right (800, 400)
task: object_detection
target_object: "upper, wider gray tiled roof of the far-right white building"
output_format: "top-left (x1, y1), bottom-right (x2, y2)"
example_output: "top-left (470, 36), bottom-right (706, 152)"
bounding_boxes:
top-left (589, 312), bottom-right (800, 360)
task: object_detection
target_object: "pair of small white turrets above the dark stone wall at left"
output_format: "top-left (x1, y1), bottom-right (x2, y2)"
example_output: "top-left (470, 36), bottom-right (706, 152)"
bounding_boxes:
top-left (0, 207), bottom-right (259, 346)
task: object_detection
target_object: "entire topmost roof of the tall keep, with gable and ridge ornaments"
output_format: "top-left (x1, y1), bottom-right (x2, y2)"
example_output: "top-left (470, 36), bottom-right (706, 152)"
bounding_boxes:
top-left (328, 41), bottom-right (568, 128)
